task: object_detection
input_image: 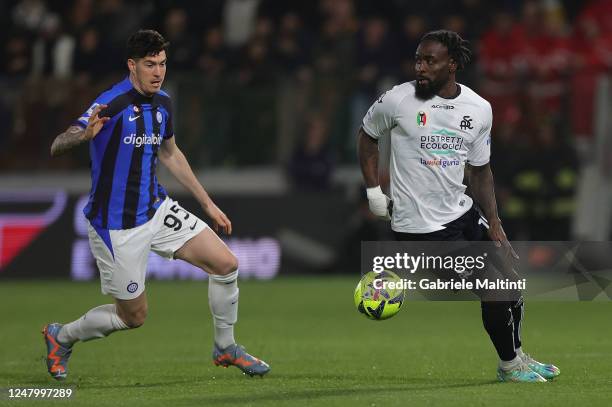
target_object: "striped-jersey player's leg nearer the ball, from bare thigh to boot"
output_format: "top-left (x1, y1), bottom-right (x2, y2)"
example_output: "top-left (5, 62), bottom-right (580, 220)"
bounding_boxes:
top-left (175, 228), bottom-right (270, 376)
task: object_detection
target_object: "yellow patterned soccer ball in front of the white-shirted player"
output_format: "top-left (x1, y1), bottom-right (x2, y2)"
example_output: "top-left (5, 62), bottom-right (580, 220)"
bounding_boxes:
top-left (354, 270), bottom-right (404, 320)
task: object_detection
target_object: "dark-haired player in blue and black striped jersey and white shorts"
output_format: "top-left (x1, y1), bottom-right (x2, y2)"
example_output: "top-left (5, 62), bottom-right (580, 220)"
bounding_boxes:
top-left (43, 30), bottom-right (270, 380)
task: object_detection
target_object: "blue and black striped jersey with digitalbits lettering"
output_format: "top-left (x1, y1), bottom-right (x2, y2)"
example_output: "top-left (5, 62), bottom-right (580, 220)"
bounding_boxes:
top-left (74, 78), bottom-right (174, 230)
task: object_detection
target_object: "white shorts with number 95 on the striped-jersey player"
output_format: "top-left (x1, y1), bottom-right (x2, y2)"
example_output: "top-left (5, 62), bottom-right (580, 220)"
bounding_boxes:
top-left (88, 198), bottom-right (208, 300)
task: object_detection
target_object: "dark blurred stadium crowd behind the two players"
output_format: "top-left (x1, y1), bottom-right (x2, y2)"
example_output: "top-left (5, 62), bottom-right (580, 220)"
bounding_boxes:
top-left (0, 0), bottom-right (612, 239)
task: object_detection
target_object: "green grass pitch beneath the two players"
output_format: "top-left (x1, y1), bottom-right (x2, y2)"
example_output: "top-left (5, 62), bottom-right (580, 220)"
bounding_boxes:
top-left (0, 277), bottom-right (612, 407)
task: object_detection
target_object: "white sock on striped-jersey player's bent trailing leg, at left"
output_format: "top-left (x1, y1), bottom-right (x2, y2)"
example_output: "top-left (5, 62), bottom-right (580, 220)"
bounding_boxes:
top-left (57, 304), bottom-right (129, 346)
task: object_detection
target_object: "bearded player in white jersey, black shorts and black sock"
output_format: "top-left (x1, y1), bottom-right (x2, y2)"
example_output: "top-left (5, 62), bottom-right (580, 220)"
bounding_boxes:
top-left (358, 30), bottom-right (560, 382)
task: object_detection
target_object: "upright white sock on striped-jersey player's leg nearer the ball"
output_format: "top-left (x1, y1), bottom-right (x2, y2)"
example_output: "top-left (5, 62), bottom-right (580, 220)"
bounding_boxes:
top-left (208, 270), bottom-right (239, 349)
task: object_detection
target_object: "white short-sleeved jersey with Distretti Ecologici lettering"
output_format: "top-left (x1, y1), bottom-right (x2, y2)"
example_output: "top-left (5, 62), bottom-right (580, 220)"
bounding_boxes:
top-left (363, 82), bottom-right (493, 233)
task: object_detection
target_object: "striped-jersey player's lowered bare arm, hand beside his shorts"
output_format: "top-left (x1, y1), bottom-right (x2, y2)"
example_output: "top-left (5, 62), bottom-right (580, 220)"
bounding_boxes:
top-left (158, 136), bottom-right (232, 235)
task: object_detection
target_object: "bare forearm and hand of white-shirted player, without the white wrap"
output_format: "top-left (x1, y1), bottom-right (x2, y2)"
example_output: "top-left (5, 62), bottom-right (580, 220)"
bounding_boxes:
top-left (469, 163), bottom-right (518, 259)
